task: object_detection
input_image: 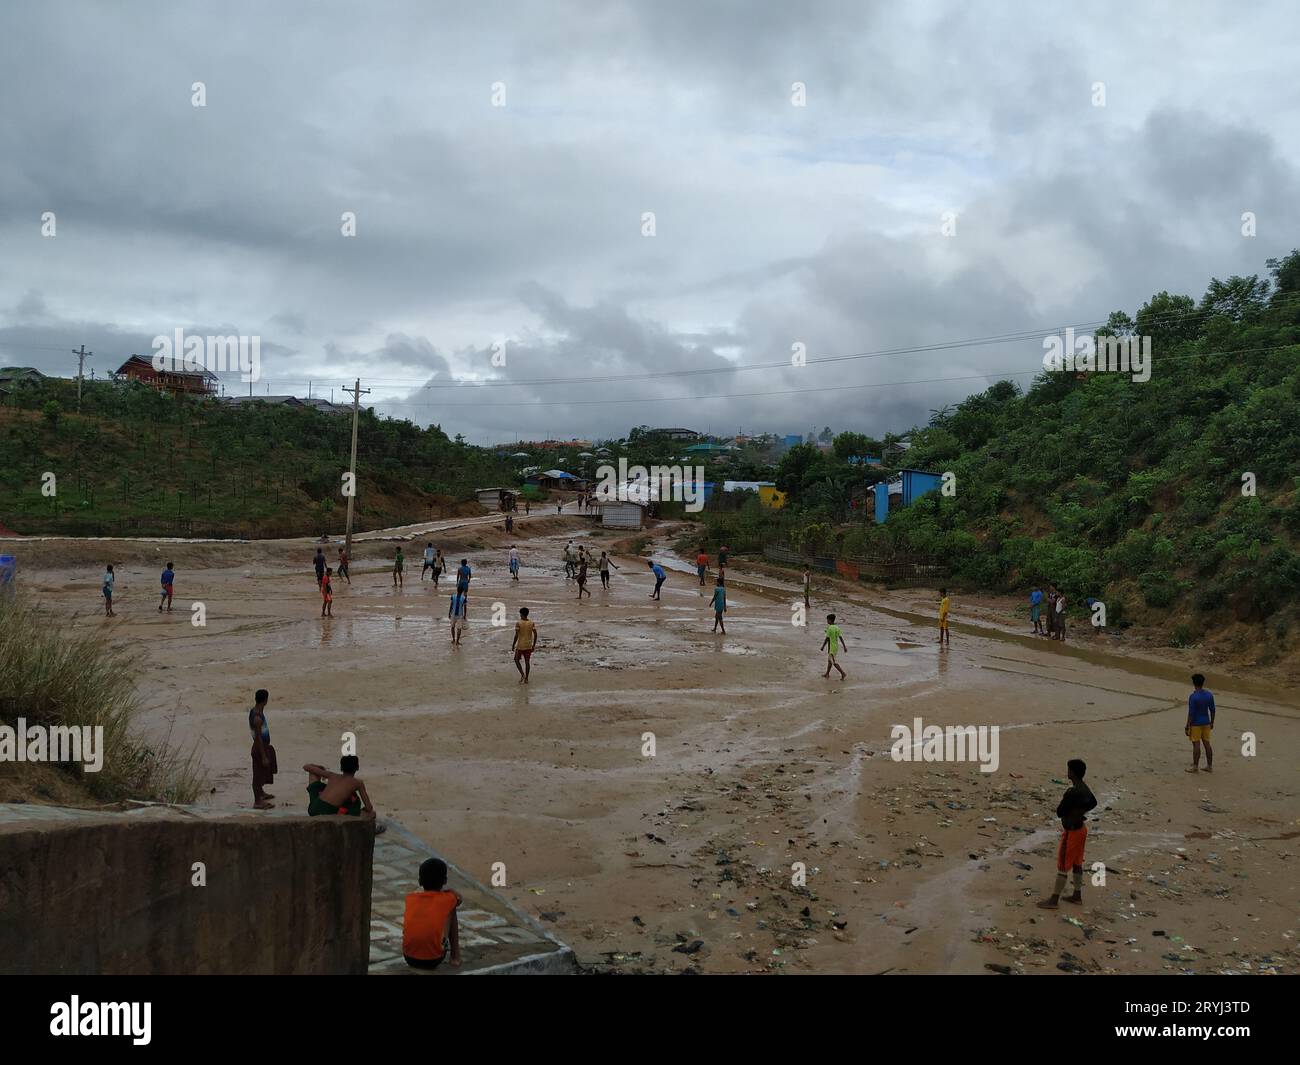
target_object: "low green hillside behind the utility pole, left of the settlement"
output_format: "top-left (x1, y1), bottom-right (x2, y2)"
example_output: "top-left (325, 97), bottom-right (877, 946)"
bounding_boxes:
top-left (0, 378), bottom-right (510, 537)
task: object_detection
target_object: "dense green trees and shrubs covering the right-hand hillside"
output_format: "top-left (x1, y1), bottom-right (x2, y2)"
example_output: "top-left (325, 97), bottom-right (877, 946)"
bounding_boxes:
top-left (706, 252), bottom-right (1300, 638)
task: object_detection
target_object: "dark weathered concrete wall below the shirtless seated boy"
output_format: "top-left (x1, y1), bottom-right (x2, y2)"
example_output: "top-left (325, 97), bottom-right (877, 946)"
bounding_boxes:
top-left (0, 810), bottom-right (374, 975)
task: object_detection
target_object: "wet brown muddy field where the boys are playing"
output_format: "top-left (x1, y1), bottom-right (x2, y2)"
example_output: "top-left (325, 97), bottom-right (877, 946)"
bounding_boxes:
top-left (10, 514), bottom-right (1300, 974)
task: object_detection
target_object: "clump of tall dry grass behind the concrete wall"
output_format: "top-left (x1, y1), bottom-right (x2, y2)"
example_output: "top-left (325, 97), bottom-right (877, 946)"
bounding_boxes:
top-left (0, 598), bottom-right (204, 802)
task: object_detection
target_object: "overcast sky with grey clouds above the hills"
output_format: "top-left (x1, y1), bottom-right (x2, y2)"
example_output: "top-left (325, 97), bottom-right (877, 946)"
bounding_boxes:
top-left (0, 0), bottom-right (1300, 443)
